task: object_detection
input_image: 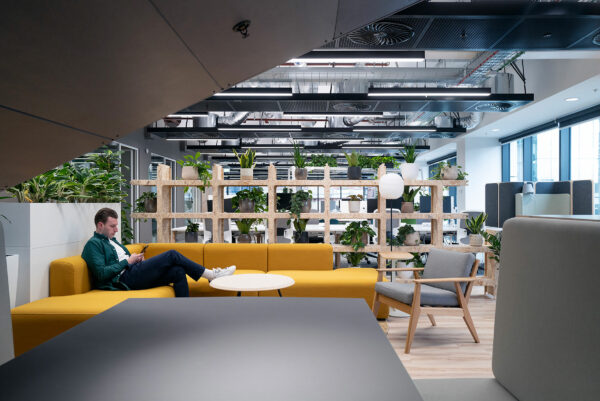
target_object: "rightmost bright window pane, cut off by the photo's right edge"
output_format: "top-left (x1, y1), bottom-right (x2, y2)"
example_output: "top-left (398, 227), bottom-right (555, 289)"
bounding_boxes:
top-left (571, 119), bottom-right (600, 214)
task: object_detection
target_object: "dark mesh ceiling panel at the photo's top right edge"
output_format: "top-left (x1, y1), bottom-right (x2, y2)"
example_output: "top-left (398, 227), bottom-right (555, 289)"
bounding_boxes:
top-left (496, 17), bottom-right (600, 49)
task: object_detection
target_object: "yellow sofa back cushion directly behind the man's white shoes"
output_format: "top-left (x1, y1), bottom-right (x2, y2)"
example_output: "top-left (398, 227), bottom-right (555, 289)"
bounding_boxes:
top-left (204, 244), bottom-right (267, 272)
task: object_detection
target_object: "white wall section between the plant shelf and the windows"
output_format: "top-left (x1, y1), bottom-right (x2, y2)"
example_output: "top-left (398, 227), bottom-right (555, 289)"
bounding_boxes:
top-left (456, 137), bottom-right (502, 211)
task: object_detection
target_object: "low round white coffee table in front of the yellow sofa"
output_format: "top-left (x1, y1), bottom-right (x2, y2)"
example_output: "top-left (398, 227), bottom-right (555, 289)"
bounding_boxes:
top-left (210, 274), bottom-right (295, 297)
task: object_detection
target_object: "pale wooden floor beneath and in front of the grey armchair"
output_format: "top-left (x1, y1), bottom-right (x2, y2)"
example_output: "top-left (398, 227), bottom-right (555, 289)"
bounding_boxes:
top-left (381, 287), bottom-right (496, 379)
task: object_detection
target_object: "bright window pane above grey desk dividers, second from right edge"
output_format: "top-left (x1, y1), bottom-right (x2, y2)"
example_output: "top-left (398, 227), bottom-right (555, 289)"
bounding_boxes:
top-left (531, 128), bottom-right (560, 181)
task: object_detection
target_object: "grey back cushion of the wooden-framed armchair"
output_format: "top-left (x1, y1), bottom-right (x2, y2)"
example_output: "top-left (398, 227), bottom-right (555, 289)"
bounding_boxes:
top-left (423, 249), bottom-right (475, 293)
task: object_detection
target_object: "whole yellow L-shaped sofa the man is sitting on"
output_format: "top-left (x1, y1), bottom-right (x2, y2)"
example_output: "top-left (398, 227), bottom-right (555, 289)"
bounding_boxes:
top-left (12, 243), bottom-right (388, 355)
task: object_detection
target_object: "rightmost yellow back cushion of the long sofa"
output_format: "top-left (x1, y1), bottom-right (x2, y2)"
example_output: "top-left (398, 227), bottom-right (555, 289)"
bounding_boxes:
top-left (268, 244), bottom-right (333, 272)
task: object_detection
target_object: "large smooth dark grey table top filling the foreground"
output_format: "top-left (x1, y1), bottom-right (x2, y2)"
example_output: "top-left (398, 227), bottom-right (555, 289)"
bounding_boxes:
top-left (0, 297), bottom-right (422, 401)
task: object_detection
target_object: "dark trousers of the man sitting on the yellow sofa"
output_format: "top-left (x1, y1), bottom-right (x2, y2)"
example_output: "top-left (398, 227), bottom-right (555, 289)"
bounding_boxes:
top-left (119, 250), bottom-right (204, 297)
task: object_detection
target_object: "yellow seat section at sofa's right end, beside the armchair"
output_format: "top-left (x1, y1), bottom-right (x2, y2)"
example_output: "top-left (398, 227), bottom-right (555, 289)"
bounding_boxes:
top-left (259, 268), bottom-right (389, 318)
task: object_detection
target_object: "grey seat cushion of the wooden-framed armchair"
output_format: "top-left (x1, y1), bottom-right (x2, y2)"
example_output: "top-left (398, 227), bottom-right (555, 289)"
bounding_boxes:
top-left (375, 281), bottom-right (458, 306)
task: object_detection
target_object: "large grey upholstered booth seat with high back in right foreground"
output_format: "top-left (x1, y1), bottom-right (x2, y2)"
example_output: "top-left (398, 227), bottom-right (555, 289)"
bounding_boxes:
top-left (415, 217), bottom-right (600, 401)
